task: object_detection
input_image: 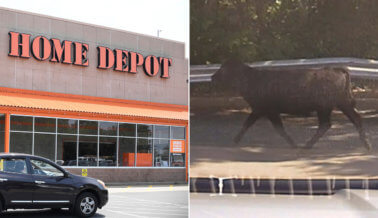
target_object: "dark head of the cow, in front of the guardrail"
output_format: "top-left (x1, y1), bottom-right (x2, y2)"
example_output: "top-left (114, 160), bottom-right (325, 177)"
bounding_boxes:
top-left (211, 59), bottom-right (246, 88)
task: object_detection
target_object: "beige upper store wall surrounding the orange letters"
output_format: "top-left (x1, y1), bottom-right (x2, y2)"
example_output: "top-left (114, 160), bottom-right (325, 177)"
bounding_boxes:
top-left (0, 8), bottom-right (188, 105)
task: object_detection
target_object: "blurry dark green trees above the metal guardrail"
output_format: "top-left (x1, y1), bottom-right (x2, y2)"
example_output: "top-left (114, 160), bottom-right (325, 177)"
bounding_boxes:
top-left (190, 0), bottom-right (378, 64)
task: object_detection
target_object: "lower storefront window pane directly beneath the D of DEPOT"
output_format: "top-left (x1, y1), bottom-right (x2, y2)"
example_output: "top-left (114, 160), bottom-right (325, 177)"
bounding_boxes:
top-left (98, 137), bottom-right (117, 167)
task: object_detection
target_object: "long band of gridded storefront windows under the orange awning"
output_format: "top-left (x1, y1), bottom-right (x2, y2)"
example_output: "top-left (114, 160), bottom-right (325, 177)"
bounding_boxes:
top-left (8, 114), bottom-right (186, 167)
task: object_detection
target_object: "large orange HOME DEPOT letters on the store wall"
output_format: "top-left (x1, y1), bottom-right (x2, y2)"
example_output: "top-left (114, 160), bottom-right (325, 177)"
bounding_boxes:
top-left (8, 32), bottom-right (172, 78)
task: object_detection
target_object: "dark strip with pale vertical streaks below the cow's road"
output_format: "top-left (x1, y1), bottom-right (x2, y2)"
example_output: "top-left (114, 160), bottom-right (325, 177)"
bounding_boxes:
top-left (190, 178), bottom-right (378, 195)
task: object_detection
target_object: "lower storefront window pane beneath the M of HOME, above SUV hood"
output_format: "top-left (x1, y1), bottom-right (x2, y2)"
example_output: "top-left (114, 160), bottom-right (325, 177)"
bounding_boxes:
top-left (56, 135), bottom-right (77, 166)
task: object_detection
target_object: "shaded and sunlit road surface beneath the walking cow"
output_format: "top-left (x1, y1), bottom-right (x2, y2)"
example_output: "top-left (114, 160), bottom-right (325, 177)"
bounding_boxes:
top-left (190, 96), bottom-right (378, 179)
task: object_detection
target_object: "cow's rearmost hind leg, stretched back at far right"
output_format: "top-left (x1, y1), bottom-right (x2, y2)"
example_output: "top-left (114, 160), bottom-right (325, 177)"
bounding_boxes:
top-left (338, 105), bottom-right (372, 150)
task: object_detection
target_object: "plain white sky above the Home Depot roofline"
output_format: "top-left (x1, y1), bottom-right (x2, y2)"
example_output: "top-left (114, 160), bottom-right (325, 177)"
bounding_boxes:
top-left (0, 0), bottom-right (189, 58)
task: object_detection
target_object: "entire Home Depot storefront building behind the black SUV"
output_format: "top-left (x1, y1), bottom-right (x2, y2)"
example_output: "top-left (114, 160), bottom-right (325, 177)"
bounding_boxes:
top-left (0, 9), bottom-right (188, 183)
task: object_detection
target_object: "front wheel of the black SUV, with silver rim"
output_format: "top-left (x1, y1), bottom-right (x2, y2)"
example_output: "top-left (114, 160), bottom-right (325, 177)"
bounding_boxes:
top-left (74, 192), bottom-right (98, 217)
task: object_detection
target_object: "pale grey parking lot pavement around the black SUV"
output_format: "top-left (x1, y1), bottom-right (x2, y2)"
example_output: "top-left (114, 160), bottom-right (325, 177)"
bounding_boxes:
top-left (3, 185), bottom-right (188, 218)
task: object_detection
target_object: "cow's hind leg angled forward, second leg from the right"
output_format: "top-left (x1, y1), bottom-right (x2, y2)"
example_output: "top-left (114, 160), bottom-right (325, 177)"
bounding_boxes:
top-left (305, 109), bottom-right (332, 148)
